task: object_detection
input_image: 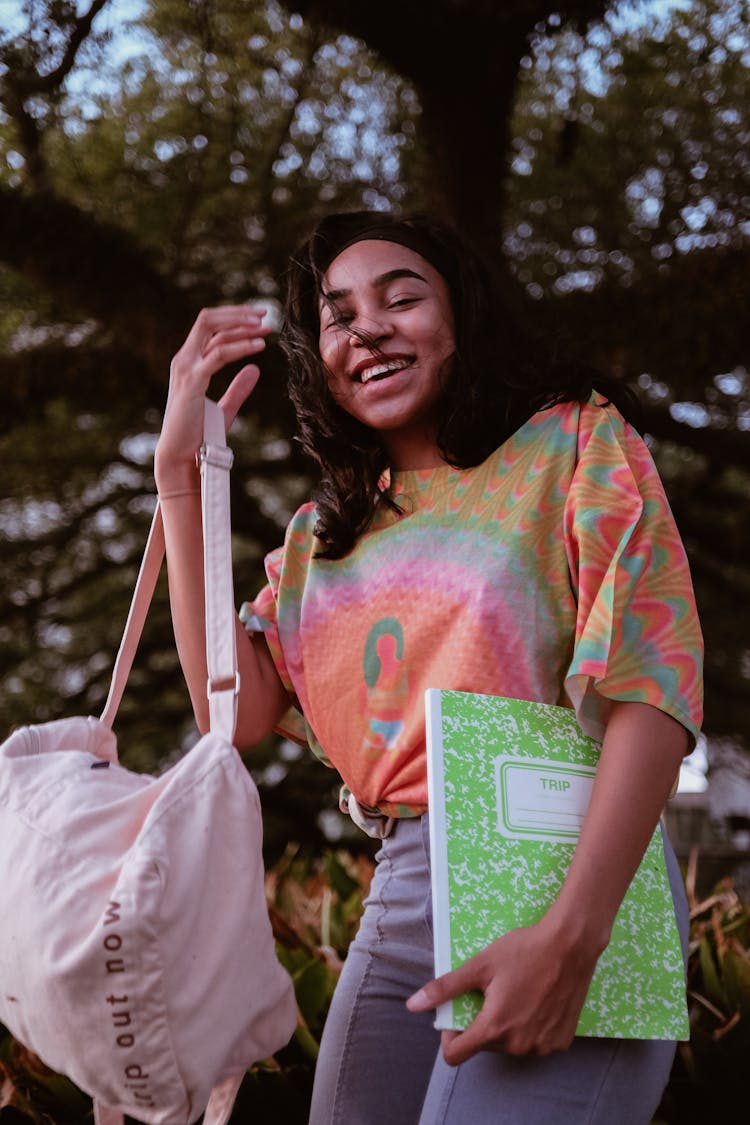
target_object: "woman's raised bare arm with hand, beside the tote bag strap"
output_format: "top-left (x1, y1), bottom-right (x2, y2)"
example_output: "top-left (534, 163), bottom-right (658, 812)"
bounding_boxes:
top-left (154, 305), bottom-right (289, 749)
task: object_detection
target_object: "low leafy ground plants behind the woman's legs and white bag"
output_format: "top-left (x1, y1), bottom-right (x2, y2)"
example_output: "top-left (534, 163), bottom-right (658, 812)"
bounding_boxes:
top-left (0, 845), bottom-right (750, 1125)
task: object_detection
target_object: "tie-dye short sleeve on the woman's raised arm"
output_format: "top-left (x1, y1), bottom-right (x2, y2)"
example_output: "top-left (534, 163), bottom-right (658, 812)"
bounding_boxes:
top-left (240, 519), bottom-right (331, 765)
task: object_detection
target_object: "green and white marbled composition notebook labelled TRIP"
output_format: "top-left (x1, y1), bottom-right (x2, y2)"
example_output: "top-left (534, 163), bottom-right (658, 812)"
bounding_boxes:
top-left (425, 690), bottom-right (689, 1040)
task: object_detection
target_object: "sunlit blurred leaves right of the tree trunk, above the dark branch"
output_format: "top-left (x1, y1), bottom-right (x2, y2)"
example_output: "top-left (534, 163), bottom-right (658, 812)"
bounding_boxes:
top-left (506, 0), bottom-right (750, 301)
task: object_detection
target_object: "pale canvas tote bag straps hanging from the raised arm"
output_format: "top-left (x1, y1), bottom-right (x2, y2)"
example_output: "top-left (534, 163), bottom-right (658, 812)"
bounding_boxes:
top-left (101, 398), bottom-right (240, 743)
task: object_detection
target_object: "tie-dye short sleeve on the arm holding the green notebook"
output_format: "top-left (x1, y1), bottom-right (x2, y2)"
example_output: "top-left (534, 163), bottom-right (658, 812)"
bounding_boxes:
top-left (564, 403), bottom-right (703, 739)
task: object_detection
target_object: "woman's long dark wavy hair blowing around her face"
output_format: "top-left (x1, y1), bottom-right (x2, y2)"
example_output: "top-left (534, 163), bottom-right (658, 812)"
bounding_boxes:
top-left (280, 212), bottom-right (638, 559)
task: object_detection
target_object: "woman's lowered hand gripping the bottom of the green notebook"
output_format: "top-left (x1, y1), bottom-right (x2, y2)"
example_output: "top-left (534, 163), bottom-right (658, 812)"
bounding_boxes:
top-left (407, 916), bottom-right (600, 1067)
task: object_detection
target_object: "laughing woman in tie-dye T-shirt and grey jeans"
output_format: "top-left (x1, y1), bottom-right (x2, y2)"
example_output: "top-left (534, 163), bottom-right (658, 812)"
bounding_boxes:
top-left (156, 213), bottom-right (701, 1125)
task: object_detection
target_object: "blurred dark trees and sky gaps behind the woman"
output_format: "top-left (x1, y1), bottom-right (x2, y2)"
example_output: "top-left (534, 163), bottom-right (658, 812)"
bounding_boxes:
top-left (0, 0), bottom-right (750, 868)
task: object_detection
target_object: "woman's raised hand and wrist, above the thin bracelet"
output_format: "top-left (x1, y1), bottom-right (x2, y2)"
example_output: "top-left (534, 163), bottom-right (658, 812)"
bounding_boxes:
top-left (155, 305), bottom-right (271, 489)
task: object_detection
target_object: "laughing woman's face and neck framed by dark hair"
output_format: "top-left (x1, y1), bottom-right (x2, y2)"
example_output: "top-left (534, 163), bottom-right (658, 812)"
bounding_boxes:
top-left (319, 239), bottom-right (455, 469)
